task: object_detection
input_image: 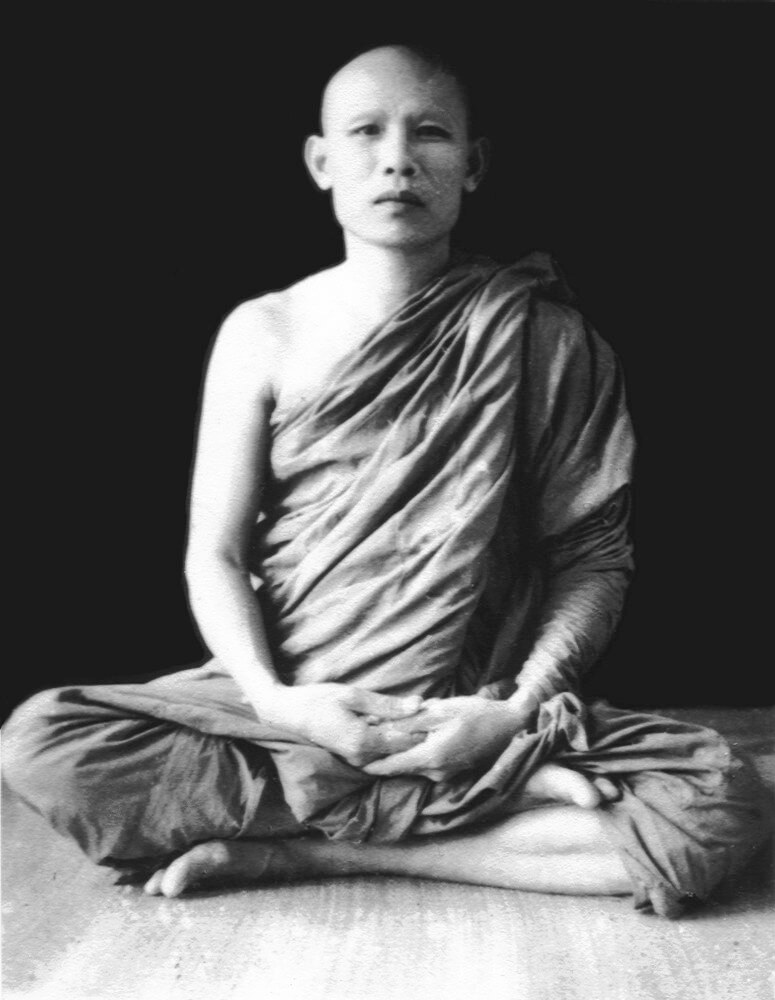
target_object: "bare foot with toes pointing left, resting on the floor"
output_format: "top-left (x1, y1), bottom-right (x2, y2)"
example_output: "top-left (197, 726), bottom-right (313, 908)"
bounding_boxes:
top-left (145, 840), bottom-right (306, 898)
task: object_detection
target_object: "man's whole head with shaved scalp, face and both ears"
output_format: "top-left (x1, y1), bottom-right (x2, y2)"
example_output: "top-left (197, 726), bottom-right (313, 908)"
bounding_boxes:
top-left (307, 48), bottom-right (478, 254)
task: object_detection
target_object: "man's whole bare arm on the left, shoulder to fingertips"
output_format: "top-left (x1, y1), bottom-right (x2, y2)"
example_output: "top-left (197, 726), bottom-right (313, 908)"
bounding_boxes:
top-left (186, 300), bottom-right (420, 765)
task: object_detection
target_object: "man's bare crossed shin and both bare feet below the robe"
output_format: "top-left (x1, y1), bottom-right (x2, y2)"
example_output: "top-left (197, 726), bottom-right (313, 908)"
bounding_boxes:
top-left (145, 764), bottom-right (632, 896)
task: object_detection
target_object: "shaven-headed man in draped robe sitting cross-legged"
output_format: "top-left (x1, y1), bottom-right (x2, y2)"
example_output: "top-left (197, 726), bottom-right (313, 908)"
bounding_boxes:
top-left (5, 46), bottom-right (771, 916)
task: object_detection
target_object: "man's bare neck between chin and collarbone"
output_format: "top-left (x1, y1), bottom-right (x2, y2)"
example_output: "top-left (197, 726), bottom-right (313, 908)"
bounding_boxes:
top-left (340, 235), bottom-right (450, 317)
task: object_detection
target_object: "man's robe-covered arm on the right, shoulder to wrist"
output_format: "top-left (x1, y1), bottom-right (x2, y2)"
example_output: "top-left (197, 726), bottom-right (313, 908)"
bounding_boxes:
top-left (514, 302), bottom-right (635, 716)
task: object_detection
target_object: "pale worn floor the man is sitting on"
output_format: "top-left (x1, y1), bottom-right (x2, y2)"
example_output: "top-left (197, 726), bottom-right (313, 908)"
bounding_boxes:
top-left (2, 709), bottom-right (775, 1000)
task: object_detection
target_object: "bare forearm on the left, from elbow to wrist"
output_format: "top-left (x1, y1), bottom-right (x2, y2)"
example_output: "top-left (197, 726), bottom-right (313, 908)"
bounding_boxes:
top-left (186, 554), bottom-right (281, 707)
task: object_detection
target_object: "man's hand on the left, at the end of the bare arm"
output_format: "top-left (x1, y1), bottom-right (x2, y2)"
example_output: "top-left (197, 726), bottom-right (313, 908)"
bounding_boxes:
top-left (253, 683), bottom-right (425, 767)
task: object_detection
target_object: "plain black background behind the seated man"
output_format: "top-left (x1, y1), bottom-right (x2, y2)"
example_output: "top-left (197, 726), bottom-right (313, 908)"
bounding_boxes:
top-left (3, 4), bottom-right (773, 720)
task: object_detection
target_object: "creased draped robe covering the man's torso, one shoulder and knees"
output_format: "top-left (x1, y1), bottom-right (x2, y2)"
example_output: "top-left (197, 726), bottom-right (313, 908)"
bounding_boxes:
top-left (5, 254), bottom-right (771, 915)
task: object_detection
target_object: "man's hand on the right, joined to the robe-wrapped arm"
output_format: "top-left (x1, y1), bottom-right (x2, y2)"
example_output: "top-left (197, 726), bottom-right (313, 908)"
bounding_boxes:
top-left (363, 695), bottom-right (532, 781)
